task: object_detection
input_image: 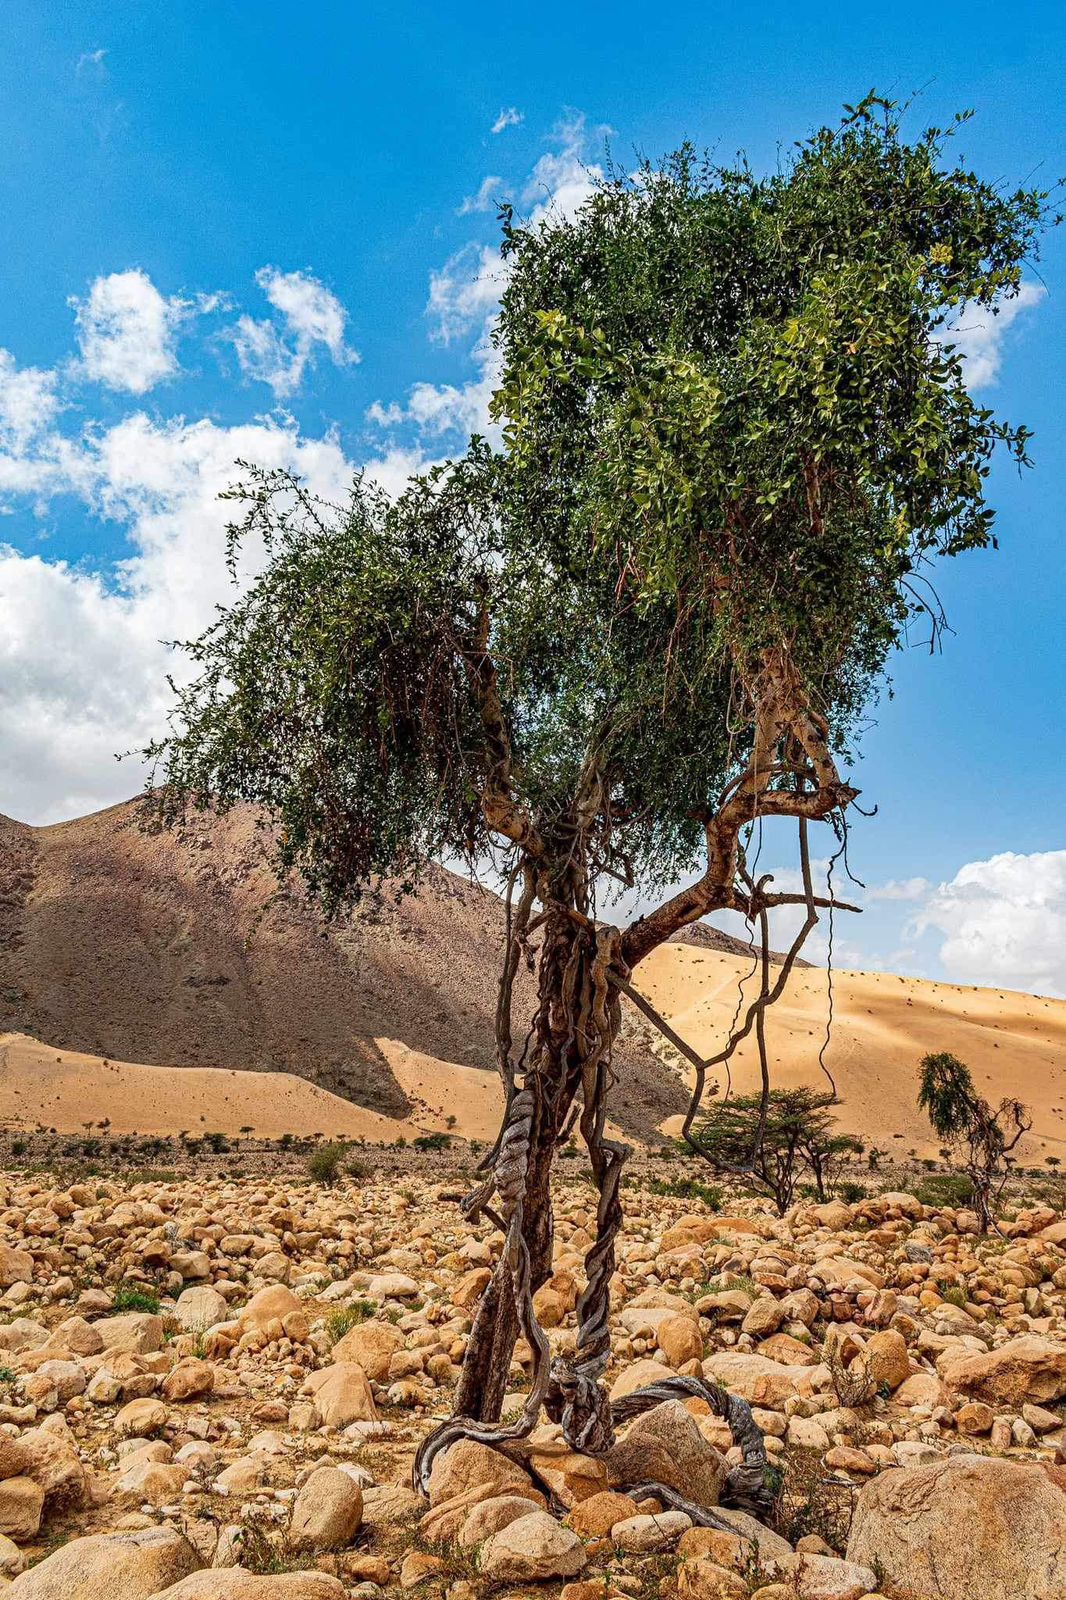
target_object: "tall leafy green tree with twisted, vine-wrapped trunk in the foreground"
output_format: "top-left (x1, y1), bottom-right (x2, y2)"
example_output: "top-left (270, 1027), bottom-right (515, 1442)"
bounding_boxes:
top-left (145, 98), bottom-right (1045, 1510)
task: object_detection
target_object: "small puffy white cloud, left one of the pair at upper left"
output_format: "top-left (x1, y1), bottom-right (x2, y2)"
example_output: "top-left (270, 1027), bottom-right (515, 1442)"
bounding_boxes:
top-left (70, 269), bottom-right (190, 395)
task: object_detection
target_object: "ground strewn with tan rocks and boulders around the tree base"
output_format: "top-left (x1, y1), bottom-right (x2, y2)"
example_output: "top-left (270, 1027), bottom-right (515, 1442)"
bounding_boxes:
top-left (0, 1163), bottom-right (1066, 1600)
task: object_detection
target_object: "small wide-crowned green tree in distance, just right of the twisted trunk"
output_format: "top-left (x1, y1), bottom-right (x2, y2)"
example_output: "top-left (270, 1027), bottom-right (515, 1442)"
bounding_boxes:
top-left (698, 1088), bottom-right (863, 1216)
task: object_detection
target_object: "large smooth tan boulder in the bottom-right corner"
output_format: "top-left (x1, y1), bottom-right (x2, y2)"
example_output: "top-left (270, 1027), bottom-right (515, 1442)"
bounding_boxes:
top-left (847, 1456), bottom-right (1066, 1600)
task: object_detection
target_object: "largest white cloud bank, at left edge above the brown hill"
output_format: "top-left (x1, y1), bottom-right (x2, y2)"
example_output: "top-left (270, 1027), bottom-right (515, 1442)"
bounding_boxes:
top-left (0, 413), bottom-right (356, 821)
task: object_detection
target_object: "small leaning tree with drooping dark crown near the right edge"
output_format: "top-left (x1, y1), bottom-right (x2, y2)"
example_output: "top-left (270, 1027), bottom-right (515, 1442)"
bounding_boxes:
top-left (919, 1051), bottom-right (1032, 1234)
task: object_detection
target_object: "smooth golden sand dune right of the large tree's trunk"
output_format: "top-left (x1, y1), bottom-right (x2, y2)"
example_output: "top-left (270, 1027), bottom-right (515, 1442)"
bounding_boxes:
top-left (635, 944), bottom-right (1066, 1162)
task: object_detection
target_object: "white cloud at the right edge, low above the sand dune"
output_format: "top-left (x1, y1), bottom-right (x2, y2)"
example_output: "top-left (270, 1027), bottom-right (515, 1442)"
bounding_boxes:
top-left (914, 850), bottom-right (1066, 997)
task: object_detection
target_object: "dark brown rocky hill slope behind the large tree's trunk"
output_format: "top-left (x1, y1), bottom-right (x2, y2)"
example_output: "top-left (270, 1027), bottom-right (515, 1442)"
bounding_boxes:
top-left (0, 802), bottom-right (683, 1133)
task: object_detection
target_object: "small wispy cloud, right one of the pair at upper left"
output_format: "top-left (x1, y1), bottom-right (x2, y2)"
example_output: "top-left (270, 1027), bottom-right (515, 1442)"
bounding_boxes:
top-left (229, 267), bottom-right (359, 400)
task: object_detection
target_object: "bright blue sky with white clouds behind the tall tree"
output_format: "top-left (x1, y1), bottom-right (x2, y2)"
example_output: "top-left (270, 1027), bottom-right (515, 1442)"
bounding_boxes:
top-left (0, 0), bottom-right (1066, 994)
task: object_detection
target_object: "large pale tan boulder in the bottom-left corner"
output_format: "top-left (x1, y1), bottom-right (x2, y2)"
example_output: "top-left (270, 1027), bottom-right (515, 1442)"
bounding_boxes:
top-left (11, 1528), bottom-right (201, 1600)
